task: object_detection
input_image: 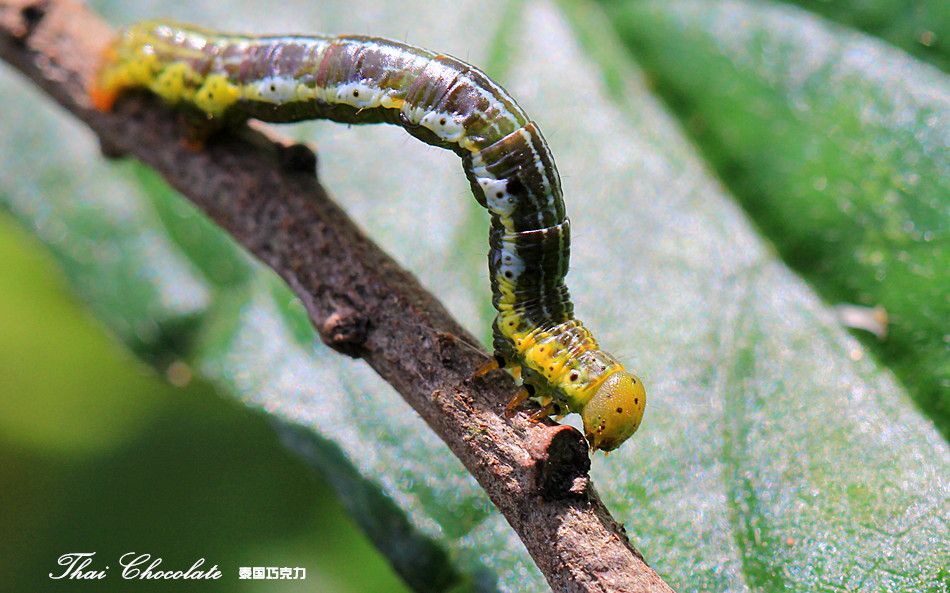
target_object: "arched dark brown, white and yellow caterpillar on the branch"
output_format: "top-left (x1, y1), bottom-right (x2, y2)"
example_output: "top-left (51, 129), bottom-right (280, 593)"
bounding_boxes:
top-left (89, 21), bottom-right (646, 452)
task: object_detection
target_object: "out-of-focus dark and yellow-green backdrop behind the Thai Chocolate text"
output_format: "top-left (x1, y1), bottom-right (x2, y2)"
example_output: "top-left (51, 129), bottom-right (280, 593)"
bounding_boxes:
top-left (0, 214), bottom-right (407, 593)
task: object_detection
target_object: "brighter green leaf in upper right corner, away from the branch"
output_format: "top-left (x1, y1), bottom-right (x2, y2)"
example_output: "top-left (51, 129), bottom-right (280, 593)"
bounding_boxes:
top-left (613, 2), bottom-right (950, 436)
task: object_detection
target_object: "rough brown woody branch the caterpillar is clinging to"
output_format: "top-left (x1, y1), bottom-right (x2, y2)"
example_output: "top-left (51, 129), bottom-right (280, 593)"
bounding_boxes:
top-left (0, 0), bottom-right (671, 593)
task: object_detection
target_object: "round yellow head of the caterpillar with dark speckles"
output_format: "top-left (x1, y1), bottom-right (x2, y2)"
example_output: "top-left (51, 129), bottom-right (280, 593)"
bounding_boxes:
top-left (581, 371), bottom-right (647, 451)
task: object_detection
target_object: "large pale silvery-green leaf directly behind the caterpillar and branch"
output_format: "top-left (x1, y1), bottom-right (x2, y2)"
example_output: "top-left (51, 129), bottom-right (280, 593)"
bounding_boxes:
top-left (0, 0), bottom-right (950, 591)
